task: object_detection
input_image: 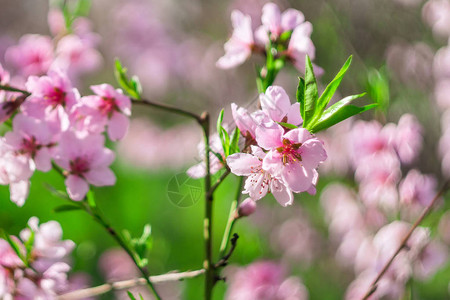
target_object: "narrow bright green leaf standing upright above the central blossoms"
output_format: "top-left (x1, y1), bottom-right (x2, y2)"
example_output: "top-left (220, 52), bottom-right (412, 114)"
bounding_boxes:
top-left (303, 56), bottom-right (319, 128)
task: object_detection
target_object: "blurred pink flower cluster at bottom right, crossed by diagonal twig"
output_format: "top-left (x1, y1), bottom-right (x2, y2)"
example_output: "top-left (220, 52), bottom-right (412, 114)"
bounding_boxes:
top-left (321, 184), bottom-right (448, 299)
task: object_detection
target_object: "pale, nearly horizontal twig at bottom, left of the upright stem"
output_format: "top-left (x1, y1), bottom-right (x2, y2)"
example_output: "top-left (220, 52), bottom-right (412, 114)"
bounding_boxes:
top-left (57, 269), bottom-right (205, 300)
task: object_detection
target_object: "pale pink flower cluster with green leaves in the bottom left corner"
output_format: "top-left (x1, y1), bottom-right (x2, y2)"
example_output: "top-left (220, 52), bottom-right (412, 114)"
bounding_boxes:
top-left (0, 217), bottom-right (75, 300)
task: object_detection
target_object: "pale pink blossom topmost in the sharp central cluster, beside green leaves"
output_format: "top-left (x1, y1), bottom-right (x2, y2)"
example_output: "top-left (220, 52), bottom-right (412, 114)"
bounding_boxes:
top-left (259, 86), bottom-right (303, 126)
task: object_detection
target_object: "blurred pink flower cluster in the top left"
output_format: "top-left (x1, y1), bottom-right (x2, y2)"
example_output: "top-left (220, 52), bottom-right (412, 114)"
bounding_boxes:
top-left (5, 9), bottom-right (102, 84)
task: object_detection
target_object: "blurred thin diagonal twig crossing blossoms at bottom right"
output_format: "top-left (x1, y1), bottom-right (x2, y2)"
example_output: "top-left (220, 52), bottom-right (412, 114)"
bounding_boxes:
top-left (361, 182), bottom-right (448, 300)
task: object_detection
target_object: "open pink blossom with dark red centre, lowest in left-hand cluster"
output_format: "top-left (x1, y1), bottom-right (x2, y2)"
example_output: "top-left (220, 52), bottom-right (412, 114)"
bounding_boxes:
top-left (55, 131), bottom-right (116, 201)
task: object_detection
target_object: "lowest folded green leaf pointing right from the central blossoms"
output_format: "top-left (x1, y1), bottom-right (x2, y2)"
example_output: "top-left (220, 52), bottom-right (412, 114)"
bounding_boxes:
top-left (307, 94), bottom-right (378, 133)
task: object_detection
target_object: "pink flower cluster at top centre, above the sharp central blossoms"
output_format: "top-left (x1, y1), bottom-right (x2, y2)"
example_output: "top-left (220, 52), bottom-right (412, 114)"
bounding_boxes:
top-left (216, 3), bottom-right (322, 73)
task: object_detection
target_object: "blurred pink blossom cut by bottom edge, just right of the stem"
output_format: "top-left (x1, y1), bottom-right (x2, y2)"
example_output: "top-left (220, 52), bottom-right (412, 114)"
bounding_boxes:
top-left (225, 261), bottom-right (308, 300)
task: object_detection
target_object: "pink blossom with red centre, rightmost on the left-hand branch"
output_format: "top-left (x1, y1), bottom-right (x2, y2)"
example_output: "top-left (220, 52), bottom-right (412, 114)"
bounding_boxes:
top-left (81, 84), bottom-right (131, 141)
